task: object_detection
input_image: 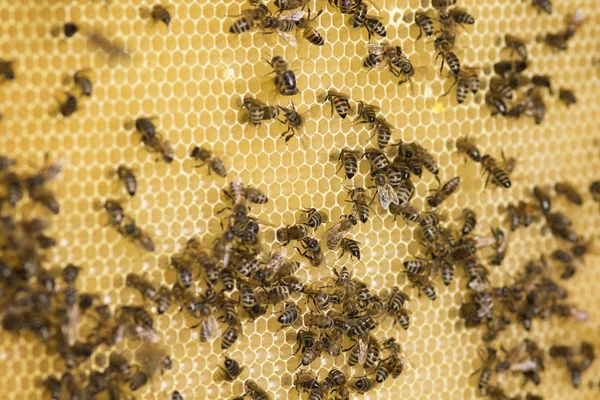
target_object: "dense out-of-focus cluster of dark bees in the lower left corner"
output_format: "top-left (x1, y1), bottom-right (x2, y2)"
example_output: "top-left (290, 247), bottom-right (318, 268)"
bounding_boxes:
top-left (0, 156), bottom-right (181, 400)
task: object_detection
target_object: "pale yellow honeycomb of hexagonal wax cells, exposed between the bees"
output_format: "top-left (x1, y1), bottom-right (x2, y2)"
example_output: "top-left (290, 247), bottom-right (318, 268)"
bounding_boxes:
top-left (0, 0), bottom-right (600, 399)
